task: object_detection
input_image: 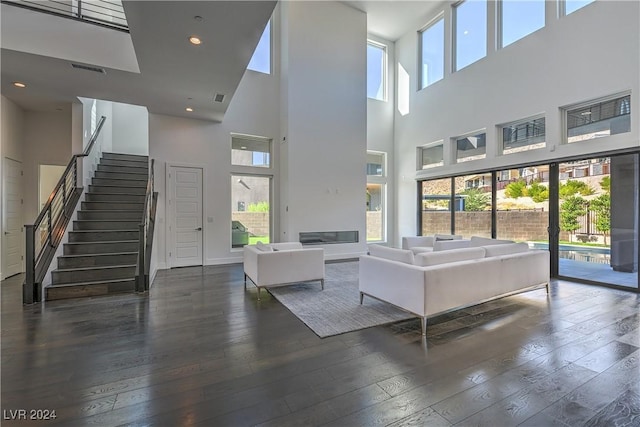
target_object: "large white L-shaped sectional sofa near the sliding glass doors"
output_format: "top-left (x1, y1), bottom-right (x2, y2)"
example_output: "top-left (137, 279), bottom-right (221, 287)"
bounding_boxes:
top-left (359, 238), bottom-right (549, 335)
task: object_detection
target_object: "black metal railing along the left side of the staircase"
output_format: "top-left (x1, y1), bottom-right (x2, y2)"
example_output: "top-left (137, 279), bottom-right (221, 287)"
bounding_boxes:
top-left (22, 116), bottom-right (106, 304)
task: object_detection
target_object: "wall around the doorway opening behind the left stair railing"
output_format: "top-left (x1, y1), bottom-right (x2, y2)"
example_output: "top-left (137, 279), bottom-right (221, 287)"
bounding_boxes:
top-left (23, 111), bottom-right (71, 224)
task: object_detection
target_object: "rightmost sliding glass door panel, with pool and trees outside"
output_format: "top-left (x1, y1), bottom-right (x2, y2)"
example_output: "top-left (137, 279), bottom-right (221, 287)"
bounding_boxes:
top-left (557, 154), bottom-right (638, 288)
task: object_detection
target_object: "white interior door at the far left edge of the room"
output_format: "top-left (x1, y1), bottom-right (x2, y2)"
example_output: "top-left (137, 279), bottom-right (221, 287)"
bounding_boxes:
top-left (2, 158), bottom-right (24, 278)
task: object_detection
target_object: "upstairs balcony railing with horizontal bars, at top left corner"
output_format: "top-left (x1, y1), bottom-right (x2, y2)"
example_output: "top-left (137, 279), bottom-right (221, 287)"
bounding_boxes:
top-left (2, 0), bottom-right (129, 33)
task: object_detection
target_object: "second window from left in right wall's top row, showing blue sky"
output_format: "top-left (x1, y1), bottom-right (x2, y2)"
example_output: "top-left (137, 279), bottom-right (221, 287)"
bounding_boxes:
top-left (453, 0), bottom-right (487, 70)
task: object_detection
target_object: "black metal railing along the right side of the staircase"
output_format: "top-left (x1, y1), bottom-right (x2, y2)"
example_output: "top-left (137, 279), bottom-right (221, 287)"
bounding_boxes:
top-left (136, 159), bottom-right (158, 292)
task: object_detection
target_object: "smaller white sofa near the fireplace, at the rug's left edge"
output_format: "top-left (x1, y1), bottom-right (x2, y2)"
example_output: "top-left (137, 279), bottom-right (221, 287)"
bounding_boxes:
top-left (243, 242), bottom-right (324, 301)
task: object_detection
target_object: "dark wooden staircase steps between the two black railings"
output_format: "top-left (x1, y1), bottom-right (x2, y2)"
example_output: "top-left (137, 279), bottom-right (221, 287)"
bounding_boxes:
top-left (45, 153), bottom-right (149, 301)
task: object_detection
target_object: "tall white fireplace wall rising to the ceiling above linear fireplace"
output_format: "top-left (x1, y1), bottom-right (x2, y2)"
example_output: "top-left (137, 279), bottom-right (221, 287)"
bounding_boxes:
top-left (281, 2), bottom-right (367, 258)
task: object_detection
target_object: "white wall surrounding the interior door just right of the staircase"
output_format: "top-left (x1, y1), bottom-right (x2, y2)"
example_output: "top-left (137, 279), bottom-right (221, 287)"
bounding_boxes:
top-left (149, 50), bottom-right (279, 269)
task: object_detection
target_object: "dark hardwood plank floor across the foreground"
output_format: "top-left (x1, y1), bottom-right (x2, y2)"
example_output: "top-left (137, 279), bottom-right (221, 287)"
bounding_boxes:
top-left (1, 265), bottom-right (640, 427)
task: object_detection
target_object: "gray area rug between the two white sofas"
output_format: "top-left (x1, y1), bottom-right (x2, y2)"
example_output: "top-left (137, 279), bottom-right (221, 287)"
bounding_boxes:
top-left (269, 262), bottom-right (415, 338)
